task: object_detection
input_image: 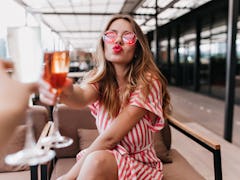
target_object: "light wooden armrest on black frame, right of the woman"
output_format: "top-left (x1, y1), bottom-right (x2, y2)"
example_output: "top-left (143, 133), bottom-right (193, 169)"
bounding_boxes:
top-left (168, 116), bottom-right (220, 150)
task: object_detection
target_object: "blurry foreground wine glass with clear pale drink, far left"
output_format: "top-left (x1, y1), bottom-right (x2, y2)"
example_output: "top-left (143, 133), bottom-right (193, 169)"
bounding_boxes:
top-left (5, 26), bottom-right (55, 165)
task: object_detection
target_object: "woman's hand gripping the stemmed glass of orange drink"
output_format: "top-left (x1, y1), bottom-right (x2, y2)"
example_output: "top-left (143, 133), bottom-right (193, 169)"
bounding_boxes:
top-left (39, 78), bottom-right (73, 105)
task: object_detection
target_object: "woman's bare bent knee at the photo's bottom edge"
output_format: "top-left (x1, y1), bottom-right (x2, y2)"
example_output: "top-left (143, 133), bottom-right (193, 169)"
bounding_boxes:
top-left (77, 150), bottom-right (118, 180)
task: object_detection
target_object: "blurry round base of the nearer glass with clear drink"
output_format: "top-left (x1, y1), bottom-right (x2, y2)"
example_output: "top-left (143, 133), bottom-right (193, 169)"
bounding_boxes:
top-left (5, 148), bottom-right (56, 166)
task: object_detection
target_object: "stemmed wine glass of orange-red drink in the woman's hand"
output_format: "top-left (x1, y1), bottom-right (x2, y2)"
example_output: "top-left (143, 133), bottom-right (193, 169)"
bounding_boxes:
top-left (42, 51), bottom-right (73, 148)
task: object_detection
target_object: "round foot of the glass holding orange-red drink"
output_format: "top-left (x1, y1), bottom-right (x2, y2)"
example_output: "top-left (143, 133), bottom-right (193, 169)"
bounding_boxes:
top-left (41, 135), bottom-right (73, 148)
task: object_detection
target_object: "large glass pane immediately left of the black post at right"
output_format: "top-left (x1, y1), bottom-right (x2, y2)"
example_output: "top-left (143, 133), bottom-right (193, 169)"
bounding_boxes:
top-left (200, 20), bottom-right (227, 99)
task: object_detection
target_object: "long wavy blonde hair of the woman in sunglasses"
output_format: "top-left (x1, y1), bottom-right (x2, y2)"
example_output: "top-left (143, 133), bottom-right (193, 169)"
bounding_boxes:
top-left (85, 15), bottom-right (170, 118)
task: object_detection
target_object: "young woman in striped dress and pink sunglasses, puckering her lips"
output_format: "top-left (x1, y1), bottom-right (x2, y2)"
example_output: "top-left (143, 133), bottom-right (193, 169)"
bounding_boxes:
top-left (40, 15), bottom-right (170, 180)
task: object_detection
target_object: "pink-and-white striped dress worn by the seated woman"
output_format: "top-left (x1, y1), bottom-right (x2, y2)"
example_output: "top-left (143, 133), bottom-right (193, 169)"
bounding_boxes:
top-left (77, 80), bottom-right (164, 180)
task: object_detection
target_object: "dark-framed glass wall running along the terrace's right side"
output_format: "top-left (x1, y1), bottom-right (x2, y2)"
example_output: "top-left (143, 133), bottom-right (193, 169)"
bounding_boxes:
top-left (156, 1), bottom-right (240, 144)
